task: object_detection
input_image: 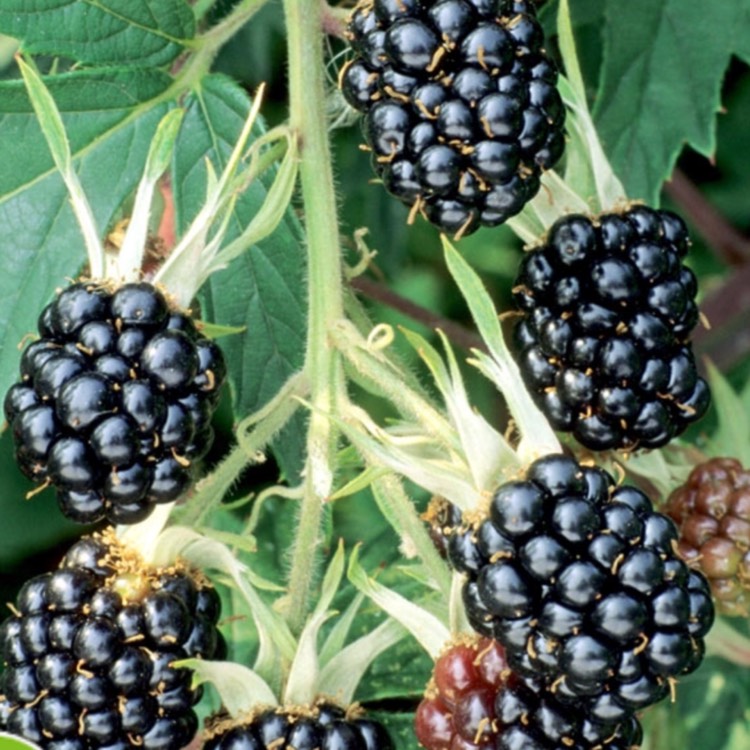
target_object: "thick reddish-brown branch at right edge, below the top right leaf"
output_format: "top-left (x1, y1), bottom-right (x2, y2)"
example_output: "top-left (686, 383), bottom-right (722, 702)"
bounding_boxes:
top-left (664, 169), bottom-right (750, 266)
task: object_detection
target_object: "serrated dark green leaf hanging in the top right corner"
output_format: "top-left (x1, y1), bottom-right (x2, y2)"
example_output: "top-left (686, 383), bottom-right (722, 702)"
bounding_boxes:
top-left (594, 0), bottom-right (744, 202)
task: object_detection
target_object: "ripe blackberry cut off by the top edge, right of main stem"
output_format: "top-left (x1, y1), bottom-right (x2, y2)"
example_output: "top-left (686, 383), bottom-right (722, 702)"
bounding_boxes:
top-left (341, 0), bottom-right (565, 234)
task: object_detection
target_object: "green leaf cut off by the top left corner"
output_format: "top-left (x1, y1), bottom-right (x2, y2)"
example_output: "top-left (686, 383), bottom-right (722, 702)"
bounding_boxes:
top-left (0, 0), bottom-right (195, 67)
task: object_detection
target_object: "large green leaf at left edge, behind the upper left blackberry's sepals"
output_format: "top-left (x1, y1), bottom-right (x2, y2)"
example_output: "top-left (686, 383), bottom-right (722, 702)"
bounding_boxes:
top-left (0, 69), bottom-right (171, 408)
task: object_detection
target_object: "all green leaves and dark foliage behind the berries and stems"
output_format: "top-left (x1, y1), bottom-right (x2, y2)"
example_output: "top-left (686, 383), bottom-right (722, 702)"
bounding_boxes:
top-left (0, 0), bottom-right (750, 750)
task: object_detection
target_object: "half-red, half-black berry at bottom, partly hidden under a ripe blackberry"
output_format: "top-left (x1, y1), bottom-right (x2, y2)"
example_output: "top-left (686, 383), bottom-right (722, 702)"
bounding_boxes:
top-left (414, 638), bottom-right (641, 750)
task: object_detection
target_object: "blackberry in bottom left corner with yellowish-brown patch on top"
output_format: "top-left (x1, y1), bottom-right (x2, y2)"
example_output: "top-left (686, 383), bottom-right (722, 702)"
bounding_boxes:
top-left (0, 532), bottom-right (224, 750)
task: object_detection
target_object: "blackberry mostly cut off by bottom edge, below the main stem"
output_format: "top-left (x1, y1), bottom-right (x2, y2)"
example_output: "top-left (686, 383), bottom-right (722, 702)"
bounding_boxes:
top-left (204, 701), bottom-right (393, 750)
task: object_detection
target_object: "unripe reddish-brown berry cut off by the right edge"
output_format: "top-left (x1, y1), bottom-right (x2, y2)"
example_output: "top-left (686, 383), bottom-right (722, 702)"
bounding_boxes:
top-left (665, 458), bottom-right (750, 616)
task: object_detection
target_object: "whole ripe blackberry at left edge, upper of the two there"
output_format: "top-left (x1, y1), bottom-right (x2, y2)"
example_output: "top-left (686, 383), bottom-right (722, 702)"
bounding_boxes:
top-left (5, 282), bottom-right (226, 523)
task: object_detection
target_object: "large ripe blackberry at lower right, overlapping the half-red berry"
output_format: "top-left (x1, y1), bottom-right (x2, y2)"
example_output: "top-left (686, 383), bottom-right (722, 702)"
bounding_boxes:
top-left (449, 455), bottom-right (714, 722)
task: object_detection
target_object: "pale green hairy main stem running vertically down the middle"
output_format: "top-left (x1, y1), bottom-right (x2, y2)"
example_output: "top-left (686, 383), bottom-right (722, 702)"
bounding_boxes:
top-left (284, 0), bottom-right (343, 633)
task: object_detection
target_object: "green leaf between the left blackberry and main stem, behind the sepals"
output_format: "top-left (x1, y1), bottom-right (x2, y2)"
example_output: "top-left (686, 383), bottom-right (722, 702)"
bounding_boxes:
top-left (173, 76), bottom-right (306, 477)
